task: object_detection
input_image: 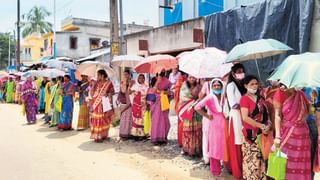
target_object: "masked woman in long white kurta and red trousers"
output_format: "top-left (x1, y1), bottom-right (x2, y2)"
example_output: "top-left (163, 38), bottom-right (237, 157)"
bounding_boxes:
top-left (227, 64), bottom-right (246, 179)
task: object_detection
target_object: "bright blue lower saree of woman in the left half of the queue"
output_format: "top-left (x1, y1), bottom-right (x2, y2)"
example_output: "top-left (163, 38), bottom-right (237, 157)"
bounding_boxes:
top-left (58, 96), bottom-right (73, 130)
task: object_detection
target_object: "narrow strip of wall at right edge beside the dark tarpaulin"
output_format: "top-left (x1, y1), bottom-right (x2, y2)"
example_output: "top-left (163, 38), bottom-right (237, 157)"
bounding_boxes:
top-left (309, 0), bottom-right (320, 52)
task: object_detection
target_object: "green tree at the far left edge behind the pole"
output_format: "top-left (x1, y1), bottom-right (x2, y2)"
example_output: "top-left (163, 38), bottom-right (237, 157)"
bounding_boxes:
top-left (0, 33), bottom-right (15, 69)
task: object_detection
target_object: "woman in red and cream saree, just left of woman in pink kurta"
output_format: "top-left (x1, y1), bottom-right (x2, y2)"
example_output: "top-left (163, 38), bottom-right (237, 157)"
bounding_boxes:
top-left (179, 76), bottom-right (202, 156)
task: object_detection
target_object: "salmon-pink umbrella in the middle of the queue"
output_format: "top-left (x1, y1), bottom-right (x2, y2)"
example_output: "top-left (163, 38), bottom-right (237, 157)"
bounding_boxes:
top-left (134, 55), bottom-right (178, 74)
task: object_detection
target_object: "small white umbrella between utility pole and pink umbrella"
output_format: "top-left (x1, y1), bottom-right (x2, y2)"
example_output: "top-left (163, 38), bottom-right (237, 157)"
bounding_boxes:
top-left (111, 55), bottom-right (144, 68)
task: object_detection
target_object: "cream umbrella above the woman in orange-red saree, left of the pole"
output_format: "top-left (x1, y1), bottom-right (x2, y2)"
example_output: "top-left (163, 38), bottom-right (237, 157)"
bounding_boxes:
top-left (77, 61), bottom-right (115, 77)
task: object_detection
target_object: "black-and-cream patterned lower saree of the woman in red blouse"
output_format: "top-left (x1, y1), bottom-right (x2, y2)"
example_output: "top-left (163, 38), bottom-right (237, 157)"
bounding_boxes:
top-left (241, 141), bottom-right (267, 180)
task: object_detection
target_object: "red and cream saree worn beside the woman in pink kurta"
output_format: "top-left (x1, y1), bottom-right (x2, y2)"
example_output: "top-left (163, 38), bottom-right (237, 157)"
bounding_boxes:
top-left (179, 82), bottom-right (202, 156)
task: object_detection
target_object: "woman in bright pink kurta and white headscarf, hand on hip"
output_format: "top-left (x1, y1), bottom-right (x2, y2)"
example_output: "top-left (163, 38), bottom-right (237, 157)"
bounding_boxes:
top-left (195, 78), bottom-right (228, 176)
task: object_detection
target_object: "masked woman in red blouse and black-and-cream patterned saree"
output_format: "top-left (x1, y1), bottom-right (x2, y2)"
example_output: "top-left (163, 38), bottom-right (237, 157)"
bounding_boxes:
top-left (240, 76), bottom-right (271, 179)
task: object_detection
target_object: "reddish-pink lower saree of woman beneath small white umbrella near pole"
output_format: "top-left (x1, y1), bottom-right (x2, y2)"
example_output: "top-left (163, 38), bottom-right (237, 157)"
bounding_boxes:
top-left (119, 104), bottom-right (132, 138)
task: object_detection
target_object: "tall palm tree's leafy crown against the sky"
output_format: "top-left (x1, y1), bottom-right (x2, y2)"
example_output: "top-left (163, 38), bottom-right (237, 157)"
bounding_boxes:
top-left (22, 6), bottom-right (52, 37)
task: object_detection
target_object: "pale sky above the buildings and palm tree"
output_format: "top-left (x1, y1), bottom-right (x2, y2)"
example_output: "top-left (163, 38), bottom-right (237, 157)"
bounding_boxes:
top-left (0, 0), bottom-right (159, 32)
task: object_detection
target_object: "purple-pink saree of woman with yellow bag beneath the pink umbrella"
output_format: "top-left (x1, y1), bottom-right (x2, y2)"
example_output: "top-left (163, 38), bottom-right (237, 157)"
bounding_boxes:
top-left (150, 78), bottom-right (171, 143)
